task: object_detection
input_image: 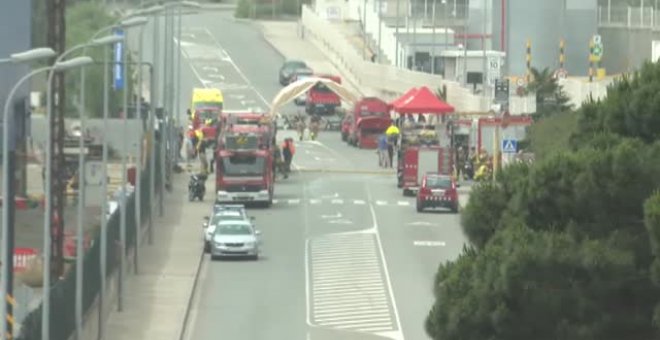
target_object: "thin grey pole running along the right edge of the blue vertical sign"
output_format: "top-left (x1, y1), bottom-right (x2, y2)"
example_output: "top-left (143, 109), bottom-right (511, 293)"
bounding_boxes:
top-left (117, 25), bottom-right (130, 312)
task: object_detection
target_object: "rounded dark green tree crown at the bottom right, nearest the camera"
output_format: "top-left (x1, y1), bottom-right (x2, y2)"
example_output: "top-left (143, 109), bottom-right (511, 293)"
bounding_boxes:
top-left (426, 224), bottom-right (658, 340)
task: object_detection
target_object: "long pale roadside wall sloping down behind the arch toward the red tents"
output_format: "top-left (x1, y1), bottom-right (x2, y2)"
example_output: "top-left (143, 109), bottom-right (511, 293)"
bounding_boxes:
top-left (301, 5), bottom-right (536, 114)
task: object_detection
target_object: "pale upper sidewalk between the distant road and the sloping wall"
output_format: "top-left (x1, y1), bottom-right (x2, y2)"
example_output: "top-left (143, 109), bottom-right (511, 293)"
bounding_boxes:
top-left (258, 21), bottom-right (365, 97)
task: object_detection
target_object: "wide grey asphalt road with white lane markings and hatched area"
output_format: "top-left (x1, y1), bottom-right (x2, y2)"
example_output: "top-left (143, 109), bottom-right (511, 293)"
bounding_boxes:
top-left (154, 12), bottom-right (464, 340)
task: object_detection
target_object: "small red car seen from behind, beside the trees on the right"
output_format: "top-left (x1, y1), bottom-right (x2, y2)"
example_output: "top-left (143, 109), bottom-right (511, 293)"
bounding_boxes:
top-left (417, 172), bottom-right (458, 213)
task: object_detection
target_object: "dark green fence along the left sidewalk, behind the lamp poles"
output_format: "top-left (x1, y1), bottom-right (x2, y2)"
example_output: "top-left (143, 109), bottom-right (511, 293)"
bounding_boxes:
top-left (16, 136), bottom-right (162, 340)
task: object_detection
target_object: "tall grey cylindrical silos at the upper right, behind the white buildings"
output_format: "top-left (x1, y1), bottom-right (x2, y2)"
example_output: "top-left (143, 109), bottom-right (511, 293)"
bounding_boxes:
top-left (488, 0), bottom-right (598, 76)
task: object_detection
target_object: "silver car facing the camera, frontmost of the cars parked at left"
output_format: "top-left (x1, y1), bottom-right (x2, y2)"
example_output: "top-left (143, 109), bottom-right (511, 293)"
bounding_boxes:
top-left (210, 220), bottom-right (261, 260)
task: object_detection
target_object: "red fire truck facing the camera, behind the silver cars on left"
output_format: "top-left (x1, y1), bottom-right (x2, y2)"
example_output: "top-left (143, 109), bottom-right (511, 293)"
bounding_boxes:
top-left (216, 131), bottom-right (275, 207)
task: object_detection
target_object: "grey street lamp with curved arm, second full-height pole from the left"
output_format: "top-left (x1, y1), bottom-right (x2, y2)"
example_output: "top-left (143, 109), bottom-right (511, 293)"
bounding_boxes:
top-left (41, 35), bottom-right (118, 340)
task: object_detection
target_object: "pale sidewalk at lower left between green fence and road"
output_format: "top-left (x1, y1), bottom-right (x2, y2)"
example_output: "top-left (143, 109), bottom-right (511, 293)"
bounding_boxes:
top-left (98, 175), bottom-right (209, 340)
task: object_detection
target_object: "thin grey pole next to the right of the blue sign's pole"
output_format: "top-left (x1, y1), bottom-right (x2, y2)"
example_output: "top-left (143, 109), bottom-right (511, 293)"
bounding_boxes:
top-left (133, 27), bottom-right (144, 274)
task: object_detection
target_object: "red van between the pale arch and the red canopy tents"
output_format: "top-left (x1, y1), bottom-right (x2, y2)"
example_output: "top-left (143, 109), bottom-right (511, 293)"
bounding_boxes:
top-left (347, 97), bottom-right (392, 149)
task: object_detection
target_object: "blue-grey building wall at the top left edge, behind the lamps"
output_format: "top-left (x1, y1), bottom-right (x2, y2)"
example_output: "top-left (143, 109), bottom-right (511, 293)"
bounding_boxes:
top-left (0, 0), bottom-right (32, 149)
